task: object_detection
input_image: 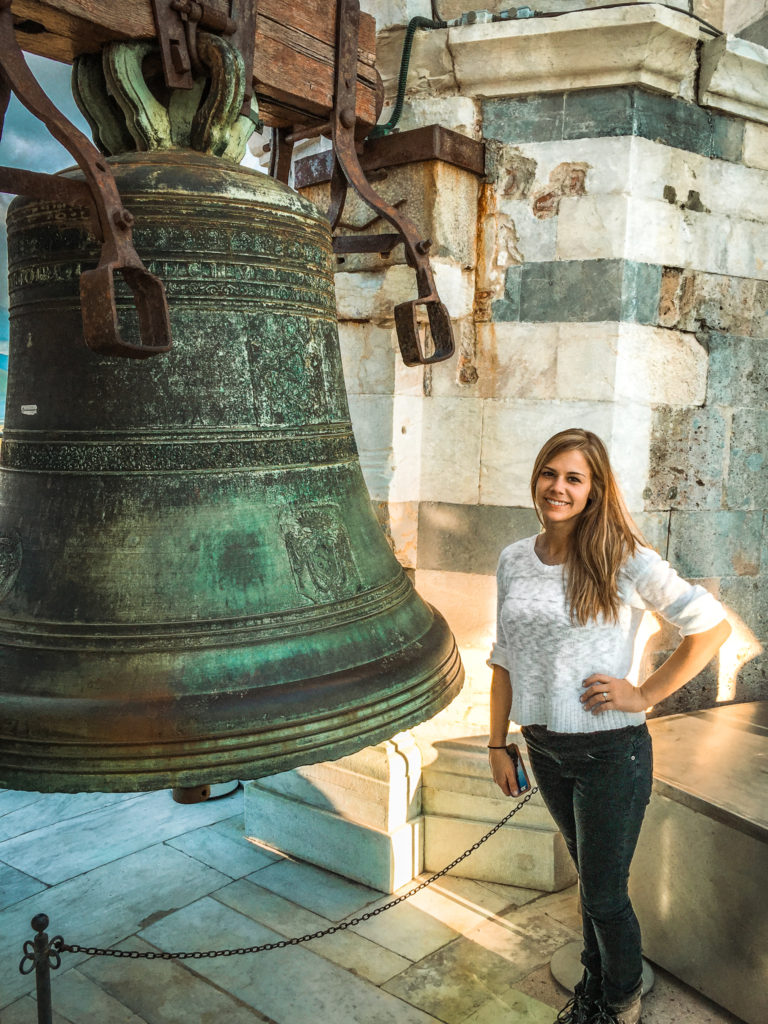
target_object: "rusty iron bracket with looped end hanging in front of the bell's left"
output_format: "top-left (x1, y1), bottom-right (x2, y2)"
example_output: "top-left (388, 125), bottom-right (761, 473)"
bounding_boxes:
top-left (0, 0), bottom-right (171, 358)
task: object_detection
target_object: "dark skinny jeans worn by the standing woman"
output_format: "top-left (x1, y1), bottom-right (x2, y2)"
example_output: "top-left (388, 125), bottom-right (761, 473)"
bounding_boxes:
top-left (522, 725), bottom-right (653, 1009)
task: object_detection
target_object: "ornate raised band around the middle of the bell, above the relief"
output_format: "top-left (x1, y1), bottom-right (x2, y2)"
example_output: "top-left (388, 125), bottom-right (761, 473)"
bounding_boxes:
top-left (2, 424), bottom-right (357, 473)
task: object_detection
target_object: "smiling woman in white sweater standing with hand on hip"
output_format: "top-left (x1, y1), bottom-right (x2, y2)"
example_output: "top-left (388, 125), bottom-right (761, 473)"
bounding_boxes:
top-left (488, 429), bottom-right (730, 1024)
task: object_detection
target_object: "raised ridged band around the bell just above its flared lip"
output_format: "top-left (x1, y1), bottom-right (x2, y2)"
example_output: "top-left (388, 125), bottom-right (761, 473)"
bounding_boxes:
top-left (0, 572), bottom-right (412, 651)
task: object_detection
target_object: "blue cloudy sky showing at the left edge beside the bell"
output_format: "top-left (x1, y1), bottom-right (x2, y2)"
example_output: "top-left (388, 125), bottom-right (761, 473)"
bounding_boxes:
top-left (0, 53), bottom-right (90, 422)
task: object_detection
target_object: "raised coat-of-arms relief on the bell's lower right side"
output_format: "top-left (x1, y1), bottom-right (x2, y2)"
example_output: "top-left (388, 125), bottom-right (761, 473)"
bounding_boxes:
top-left (280, 505), bottom-right (360, 603)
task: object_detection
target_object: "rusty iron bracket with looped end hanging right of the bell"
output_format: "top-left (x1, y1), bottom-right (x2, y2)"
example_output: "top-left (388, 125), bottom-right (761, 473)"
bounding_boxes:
top-left (328, 0), bottom-right (455, 367)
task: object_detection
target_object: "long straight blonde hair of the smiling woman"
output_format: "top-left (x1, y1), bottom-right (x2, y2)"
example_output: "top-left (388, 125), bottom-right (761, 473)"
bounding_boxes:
top-left (530, 428), bottom-right (645, 626)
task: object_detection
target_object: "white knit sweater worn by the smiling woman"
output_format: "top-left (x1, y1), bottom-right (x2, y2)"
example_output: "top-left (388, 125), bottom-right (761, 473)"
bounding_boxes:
top-left (488, 537), bottom-right (725, 732)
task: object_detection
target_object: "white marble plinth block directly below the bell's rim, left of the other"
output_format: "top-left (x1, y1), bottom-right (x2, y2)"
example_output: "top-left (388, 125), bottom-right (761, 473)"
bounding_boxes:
top-left (245, 732), bottom-right (423, 893)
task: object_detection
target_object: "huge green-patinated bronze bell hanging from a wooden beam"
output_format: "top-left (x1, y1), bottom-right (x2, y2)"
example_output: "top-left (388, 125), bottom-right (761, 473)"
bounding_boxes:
top-left (0, 37), bottom-right (463, 792)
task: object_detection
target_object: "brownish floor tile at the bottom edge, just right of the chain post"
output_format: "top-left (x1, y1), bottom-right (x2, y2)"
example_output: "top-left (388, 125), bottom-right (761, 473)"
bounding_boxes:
top-left (78, 937), bottom-right (269, 1024)
